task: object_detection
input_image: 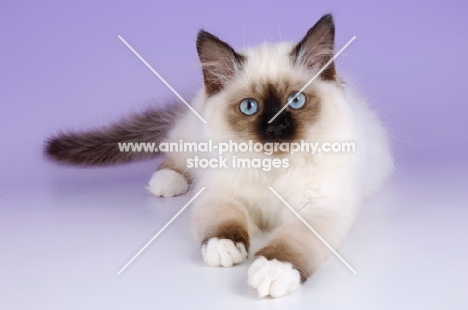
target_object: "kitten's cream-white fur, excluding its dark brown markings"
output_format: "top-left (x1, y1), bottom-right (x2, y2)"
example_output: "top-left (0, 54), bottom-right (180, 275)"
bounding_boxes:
top-left (152, 43), bottom-right (393, 297)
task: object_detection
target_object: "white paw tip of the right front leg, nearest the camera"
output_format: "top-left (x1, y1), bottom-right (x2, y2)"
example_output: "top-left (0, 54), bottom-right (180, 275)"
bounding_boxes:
top-left (248, 256), bottom-right (301, 298)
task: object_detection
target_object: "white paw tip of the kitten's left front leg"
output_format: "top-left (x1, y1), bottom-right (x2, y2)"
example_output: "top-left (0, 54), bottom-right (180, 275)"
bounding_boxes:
top-left (202, 238), bottom-right (247, 267)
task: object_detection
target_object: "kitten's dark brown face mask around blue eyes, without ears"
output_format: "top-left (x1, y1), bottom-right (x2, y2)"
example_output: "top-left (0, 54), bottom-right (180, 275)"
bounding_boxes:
top-left (223, 57), bottom-right (320, 142)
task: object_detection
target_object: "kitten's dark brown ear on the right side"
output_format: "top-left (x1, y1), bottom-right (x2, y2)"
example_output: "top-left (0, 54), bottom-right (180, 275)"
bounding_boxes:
top-left (291, 14), bottom-right (336, 81)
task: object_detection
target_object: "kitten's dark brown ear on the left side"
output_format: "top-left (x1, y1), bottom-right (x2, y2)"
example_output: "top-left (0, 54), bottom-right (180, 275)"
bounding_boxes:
top-left (197, 30), bottom-right (244, 95)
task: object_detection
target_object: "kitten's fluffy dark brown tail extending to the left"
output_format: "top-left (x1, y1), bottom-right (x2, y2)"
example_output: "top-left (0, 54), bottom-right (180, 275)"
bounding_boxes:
top-left (44, 105), bottom-right (182, 166)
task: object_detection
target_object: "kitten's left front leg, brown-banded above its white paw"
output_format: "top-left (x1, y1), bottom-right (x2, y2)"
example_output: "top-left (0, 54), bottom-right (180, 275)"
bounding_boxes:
top-left (194, 200), bottom-right (250, 267)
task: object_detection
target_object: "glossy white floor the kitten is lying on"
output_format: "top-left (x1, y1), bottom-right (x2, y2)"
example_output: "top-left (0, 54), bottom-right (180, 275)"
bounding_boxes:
top-left (0, 170), bottom-right (468, 310)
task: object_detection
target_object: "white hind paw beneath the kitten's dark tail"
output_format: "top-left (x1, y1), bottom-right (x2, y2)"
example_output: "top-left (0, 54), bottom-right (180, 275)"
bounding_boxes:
top-left (147, 169), bottom-right (188, 197)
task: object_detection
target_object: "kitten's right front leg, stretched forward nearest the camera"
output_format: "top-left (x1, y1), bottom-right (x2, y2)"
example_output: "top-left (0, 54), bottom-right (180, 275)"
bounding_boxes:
top-left (248, 215), bottom-right (348, 297)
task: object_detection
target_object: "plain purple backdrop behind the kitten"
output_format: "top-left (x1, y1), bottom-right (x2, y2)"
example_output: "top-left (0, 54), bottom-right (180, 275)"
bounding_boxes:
top-left (0, 0), bottom-right (468, 190)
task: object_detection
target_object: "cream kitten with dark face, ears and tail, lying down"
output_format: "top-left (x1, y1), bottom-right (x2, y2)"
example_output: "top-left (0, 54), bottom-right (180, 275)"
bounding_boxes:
top-left (45, 14), bottom-right (393, 297)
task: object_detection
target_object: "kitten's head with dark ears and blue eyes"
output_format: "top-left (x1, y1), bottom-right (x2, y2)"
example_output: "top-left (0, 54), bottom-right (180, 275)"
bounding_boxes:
top-left (197, 15), bottom-right (336, 147)
